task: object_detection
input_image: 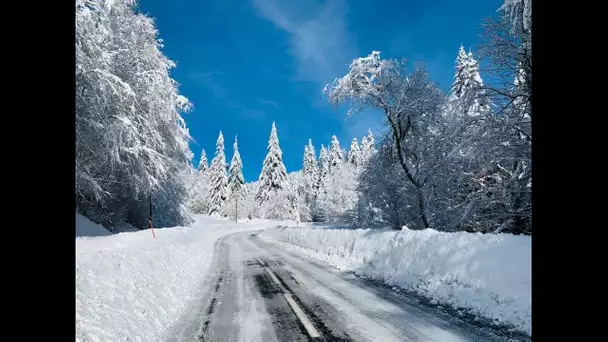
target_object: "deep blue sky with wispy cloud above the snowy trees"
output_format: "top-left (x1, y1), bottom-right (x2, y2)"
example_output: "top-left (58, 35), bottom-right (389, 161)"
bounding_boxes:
top-left (139, 0), bottom-right (503, 181)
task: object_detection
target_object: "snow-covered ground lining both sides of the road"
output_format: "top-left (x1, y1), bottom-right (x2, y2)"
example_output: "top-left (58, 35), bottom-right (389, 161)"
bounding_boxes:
top-left (76, 214), bottom-right (531, 341)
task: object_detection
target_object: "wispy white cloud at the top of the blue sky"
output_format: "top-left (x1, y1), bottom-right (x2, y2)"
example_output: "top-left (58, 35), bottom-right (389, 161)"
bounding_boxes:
top-left (254, 0), bottom-right (357, 85)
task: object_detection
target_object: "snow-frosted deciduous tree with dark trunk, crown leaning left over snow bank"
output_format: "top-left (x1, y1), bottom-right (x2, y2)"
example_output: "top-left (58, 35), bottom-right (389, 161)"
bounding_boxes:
top-left (324, 51), bottom-right (452, 228)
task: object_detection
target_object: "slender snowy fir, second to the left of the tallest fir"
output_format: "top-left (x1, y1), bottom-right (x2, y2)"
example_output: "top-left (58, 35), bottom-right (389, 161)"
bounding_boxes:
top-left (209, 131), bottom-right (228, 216)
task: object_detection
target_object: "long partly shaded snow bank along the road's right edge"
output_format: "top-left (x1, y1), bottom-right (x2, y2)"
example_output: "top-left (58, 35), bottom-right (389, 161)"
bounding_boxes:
top-left (260, 228), bottom-right (532, 334)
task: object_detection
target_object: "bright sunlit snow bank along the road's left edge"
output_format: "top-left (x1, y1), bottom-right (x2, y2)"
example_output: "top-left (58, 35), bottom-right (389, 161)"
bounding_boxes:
top-left (76, 216), bottom-right (267, 341)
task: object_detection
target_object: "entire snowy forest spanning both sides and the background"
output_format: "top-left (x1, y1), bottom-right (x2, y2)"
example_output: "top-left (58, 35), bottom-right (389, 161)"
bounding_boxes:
top-left (75, 0), bottom-right (532, 234)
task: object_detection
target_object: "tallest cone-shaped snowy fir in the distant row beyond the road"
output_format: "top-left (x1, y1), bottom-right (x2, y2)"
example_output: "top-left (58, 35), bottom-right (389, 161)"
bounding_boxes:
top-left (255, 122), bottom-right (287, 217)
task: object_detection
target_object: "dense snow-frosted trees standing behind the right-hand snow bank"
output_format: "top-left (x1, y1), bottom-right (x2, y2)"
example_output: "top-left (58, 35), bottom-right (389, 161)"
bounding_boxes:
top-left (324, 0), bottom-right (532, 234)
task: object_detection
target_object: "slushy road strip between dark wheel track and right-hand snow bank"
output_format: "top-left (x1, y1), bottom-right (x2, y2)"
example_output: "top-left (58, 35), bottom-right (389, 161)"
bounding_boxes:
top-left (248, 235), bottom-right (503, 341)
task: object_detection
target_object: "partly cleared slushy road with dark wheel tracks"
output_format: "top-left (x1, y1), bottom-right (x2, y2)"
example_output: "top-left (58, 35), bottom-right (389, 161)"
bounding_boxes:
top-left (166, 231), bottom-right (512, 341)
